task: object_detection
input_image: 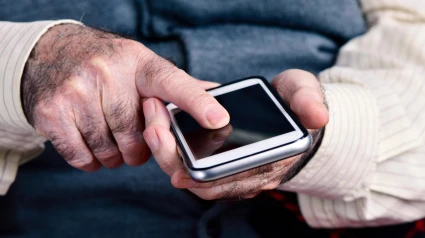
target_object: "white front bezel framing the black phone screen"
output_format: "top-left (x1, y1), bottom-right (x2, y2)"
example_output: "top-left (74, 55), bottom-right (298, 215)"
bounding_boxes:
top-left (167, 78), bottom-right (304, 170)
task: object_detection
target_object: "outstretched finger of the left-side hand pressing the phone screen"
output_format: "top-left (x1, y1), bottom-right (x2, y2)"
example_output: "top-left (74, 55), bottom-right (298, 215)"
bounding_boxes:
top-left (136, 53), bottom-right (230, 129)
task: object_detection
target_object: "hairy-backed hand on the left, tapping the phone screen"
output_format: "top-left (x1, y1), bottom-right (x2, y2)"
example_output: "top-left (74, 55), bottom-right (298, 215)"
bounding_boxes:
top-left (22, 24), bottom-right (229, 171)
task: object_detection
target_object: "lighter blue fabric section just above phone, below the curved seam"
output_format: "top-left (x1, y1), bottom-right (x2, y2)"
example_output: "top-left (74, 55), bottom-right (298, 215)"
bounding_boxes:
top-left (176, 25), bottom-right (338, 82)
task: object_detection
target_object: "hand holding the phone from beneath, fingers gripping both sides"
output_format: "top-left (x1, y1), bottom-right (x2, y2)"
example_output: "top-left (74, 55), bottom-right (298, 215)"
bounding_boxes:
top-left (143, 70), bottom-right (328, 200)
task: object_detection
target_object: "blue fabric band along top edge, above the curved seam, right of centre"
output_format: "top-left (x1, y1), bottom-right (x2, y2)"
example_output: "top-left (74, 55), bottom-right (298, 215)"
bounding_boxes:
top-left (141, 0), bottom-right (365, 42)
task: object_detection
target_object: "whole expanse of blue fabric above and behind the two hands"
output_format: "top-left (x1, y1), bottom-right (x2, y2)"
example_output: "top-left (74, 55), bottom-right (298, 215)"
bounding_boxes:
top-left (0, 0), bottom-right (365, 82)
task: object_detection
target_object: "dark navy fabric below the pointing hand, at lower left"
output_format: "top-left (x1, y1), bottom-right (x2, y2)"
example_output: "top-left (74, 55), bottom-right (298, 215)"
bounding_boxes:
top-left (0, 144), bottom-right (209, 237)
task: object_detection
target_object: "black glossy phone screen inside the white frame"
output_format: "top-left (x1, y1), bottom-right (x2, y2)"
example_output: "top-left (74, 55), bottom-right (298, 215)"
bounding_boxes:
top-left (175, 84), bottom-right (295, 160)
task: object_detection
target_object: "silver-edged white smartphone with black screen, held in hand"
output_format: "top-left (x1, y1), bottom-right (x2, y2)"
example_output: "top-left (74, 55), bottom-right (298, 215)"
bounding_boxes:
top-left (167, 76), bottom-right (311, 182)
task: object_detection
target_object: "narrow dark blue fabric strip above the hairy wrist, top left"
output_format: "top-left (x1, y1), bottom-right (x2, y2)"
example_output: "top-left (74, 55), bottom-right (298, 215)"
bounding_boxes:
top-left (0, 0), bottom-right (139, 35)
